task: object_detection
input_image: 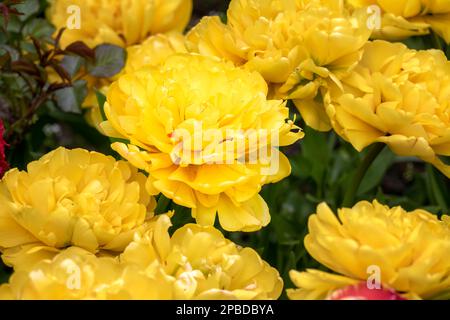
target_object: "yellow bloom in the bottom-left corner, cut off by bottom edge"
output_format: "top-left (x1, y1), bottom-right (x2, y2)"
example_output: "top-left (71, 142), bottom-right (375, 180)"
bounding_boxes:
top-left (0, 247), bottom-right (172, 300)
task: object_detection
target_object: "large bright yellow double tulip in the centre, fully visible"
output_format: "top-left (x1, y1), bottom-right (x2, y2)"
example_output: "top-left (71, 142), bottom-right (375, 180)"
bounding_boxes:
top-left (101, 54), bottom-right (303, 231)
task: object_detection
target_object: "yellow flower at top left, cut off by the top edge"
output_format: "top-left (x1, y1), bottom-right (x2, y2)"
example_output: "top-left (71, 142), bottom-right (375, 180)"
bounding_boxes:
top-left (47, 0), bottom-right (192, 47)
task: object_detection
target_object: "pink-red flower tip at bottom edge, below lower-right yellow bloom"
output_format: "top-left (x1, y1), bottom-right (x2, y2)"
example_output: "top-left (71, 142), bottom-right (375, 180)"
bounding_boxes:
top-left (328, 282), bottom-right (406, 300)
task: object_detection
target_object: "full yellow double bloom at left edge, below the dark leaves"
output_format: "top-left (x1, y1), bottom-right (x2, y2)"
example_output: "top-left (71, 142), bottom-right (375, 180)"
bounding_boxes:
top-left (0, 148), bottom-right (155, 266)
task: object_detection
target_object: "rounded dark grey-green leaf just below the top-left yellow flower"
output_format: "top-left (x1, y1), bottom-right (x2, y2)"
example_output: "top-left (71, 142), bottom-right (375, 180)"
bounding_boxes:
top-left (88, 44), bottom-right (127, 78)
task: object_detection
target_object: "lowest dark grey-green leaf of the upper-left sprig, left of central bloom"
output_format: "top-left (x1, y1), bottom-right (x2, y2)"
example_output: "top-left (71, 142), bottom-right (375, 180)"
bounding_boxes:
top-left (55, 80), bottom-right (87, 113)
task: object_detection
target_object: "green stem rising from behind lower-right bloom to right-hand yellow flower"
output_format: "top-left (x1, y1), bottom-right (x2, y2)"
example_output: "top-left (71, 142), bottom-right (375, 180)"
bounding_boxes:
top-left (342, 143), bottom-right (385, 207)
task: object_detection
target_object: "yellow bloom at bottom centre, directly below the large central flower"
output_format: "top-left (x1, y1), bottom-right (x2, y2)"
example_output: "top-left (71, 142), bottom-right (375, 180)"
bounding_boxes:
top-left (120, 215), bottom-right (283, 300)
